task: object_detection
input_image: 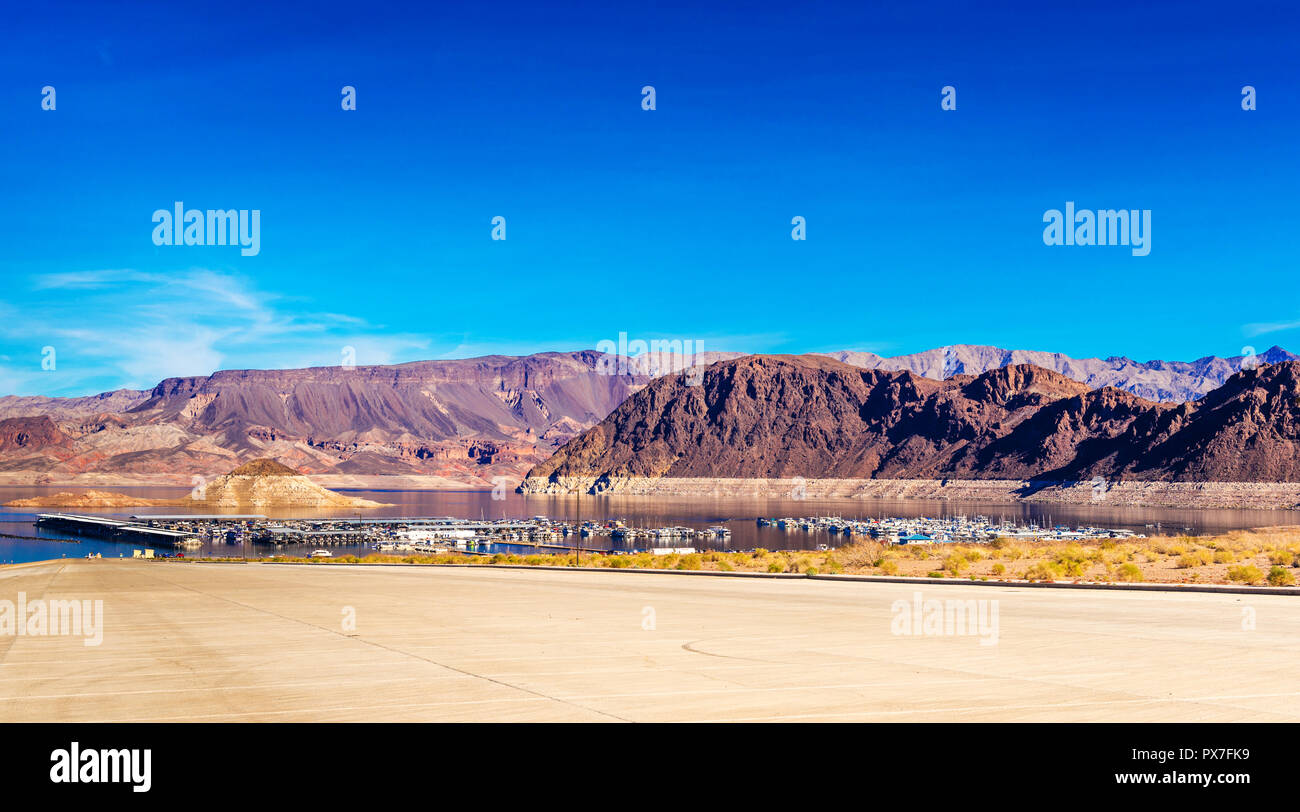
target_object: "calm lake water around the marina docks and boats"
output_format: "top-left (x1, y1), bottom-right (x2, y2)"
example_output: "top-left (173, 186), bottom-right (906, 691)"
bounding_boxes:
top-left (0, 486), bottom-right (1300, 563)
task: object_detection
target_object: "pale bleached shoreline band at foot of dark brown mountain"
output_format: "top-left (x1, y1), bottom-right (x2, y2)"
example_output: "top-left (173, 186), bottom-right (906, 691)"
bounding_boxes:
top-left (519, 477), bottom-right (1300, 509)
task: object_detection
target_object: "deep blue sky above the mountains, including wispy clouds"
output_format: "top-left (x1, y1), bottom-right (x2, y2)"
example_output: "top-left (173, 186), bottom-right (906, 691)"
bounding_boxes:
top-left (0, 3), bottom-right (1300, 395)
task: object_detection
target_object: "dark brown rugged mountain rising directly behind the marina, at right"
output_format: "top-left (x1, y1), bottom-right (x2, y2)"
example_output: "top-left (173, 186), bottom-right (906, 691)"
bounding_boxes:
top-left (524, 356), bottom-right (1300, 491)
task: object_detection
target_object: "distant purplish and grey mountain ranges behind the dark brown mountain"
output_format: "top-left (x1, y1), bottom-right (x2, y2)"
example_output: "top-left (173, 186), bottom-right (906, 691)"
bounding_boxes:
top-left (0, 346), bottom-right (1296, 487)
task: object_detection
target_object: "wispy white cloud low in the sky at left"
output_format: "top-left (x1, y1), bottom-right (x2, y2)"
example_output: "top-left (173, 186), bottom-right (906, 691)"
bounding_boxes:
top-left (0, 269), bottom-right (429, 395)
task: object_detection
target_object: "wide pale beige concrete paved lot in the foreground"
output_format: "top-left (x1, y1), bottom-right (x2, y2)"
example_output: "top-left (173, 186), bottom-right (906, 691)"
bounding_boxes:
top-left (0, 560), bottom-right (1300, 721)
